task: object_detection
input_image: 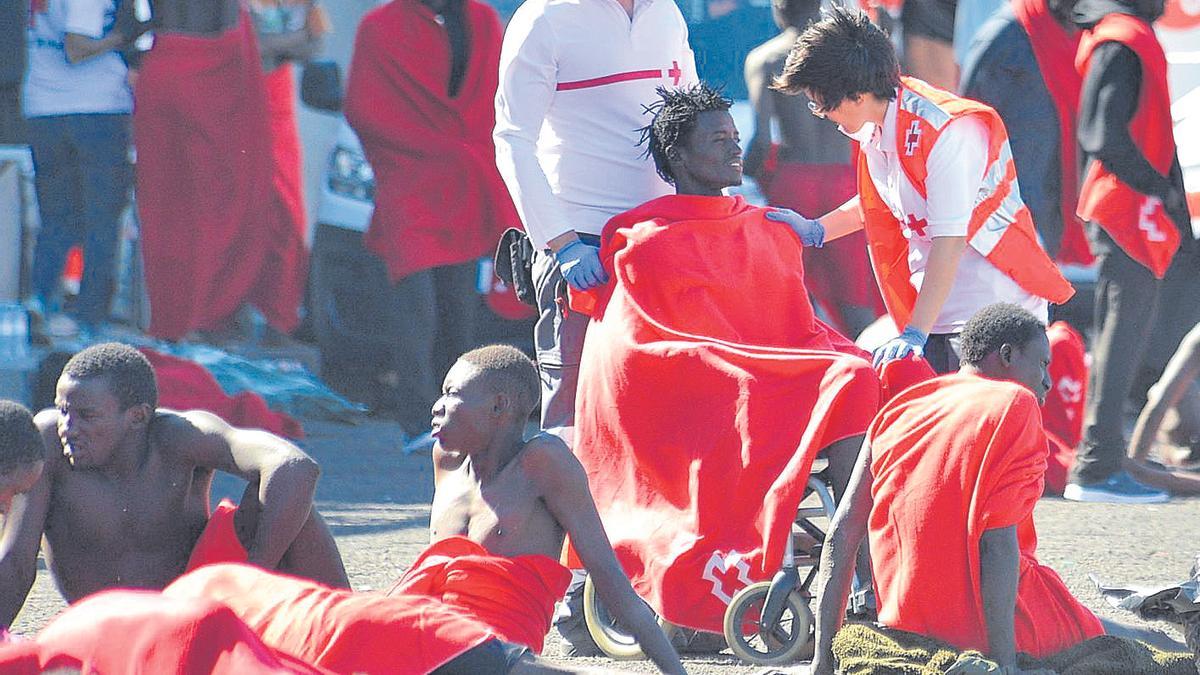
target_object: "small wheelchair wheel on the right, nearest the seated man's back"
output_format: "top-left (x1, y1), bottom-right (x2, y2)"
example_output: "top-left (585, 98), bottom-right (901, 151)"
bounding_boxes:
top-left (725, 581), bottom-right (812, 665)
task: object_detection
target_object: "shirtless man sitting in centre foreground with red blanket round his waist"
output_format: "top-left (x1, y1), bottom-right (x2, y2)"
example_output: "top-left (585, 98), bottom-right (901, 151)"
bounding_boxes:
top-left (408, 345), bottom-right (684, 673)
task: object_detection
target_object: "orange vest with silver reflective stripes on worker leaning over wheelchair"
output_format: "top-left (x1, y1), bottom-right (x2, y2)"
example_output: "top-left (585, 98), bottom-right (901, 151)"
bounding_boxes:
top-left (858, 77), bottom-right (1075, 329)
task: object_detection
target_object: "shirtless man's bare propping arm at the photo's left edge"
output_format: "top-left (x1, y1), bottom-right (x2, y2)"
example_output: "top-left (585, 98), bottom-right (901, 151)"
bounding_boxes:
top-left (0, 411), bottom-right (62, 628)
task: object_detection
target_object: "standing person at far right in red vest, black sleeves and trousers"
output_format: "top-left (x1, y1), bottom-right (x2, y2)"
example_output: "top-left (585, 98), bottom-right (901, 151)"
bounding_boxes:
top-left (1063, 0), bottom-right (1196, 503)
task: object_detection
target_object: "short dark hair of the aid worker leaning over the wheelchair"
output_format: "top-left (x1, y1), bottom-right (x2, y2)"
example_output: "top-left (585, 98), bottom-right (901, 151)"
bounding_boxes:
top-left (772, 6), bottom-right (900, 108)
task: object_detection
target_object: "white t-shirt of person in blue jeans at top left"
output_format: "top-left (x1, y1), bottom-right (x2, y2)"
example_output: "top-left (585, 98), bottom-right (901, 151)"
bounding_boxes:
top-left (23, 0), bottom-right (133, 118)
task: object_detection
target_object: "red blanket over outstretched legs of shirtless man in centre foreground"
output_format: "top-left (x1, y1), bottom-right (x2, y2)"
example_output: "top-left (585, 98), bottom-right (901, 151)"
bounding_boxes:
top-left (163, 565), bottom-right (493, 675)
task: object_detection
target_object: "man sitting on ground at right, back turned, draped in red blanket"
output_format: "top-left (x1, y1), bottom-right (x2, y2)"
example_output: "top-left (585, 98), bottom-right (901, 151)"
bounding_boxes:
top-left (812, 303), bottom-right (1182, 674)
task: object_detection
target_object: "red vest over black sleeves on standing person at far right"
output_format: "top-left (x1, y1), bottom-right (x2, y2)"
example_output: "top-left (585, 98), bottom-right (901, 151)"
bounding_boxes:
top-left (1075, 13), bottom-right (1181, 273)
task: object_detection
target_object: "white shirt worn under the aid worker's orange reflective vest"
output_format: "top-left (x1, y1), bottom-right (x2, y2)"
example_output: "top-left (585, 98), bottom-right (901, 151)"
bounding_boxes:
top-left (860, 101), bottom-right (1049, 334)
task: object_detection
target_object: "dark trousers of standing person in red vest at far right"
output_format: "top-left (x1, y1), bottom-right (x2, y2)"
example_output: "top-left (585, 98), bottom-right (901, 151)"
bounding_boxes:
top-left (1070, 223), bottom-right (1162, 483)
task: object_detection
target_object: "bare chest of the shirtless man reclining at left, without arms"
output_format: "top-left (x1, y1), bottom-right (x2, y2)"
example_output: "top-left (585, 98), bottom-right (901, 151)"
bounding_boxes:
top-left (38, 411), bottom-right (212, 602)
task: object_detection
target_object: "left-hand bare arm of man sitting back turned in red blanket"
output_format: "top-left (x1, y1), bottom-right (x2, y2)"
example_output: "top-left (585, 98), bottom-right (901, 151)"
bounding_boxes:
top-left (812, 441), bottom-right (874, 675)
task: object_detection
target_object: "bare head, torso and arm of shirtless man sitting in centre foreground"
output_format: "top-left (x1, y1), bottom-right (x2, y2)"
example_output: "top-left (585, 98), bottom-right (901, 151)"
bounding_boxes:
top-left (430, 345), bottom-right (684, 673)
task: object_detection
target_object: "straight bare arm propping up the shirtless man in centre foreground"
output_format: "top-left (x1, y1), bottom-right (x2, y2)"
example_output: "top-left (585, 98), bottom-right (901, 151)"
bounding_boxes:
top-left (523, 435), bottom-right (685, 674)
